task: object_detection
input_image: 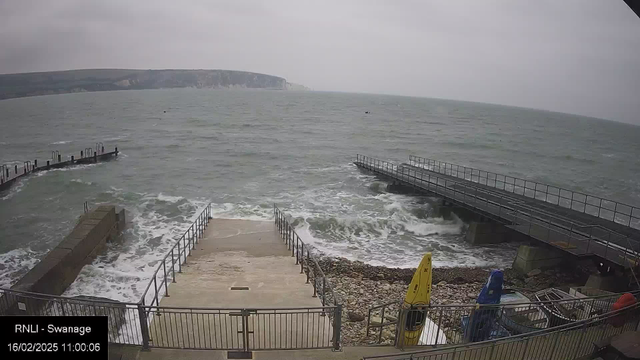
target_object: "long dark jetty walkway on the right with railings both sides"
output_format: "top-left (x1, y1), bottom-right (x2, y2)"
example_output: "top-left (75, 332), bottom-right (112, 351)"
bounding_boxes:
top-left (355, 155), bottom-right (640, 268)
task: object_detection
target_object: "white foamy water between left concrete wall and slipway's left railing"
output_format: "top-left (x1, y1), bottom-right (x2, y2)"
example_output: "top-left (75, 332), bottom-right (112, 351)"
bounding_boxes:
top-left (64, 187), bottom-right (207, 302)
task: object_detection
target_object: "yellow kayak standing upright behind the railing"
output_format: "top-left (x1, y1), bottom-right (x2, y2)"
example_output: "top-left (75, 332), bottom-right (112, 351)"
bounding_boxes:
top-left (403, 253), bottom-right (431, 346)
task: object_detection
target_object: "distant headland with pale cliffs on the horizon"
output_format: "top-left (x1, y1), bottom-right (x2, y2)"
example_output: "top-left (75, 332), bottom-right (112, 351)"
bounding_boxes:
top-left (0, 69), bottom-right (309, 100)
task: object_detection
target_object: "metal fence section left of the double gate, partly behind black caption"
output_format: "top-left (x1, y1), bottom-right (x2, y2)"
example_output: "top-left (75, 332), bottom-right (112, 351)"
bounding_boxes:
top-left (0, 289), bottom-right (143, 345)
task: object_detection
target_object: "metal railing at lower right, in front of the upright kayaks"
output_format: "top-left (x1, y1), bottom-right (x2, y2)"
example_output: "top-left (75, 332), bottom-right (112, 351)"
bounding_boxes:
top-left (367, 291), bottom-right (640, 348)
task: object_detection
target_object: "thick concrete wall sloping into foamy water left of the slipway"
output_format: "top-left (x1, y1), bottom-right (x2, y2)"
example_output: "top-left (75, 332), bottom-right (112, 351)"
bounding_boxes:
top-left (11, 206), bottom-right (124, 295)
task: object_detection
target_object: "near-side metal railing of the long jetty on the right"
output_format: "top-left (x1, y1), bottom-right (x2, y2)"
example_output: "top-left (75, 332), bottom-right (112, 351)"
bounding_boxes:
top-left (356, 154), bottom-right (640, 267)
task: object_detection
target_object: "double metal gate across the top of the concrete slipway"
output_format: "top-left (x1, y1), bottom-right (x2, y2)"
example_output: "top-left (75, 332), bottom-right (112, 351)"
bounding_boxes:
top-left (142, 306), bottom-right (342, 353)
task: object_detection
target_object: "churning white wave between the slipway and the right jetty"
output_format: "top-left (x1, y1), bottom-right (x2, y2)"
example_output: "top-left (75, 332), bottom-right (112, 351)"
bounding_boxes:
top-left (206, 173), bottom-right (517, 267)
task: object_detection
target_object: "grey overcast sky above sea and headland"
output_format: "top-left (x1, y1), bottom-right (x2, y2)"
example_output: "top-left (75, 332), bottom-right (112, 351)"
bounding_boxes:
top-left (0, 0), bottom-right (640, 124)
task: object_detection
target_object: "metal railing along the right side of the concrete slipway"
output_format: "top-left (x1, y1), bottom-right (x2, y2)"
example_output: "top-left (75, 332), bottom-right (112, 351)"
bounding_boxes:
top-left (273, 204), bottom-right (340, 306)
